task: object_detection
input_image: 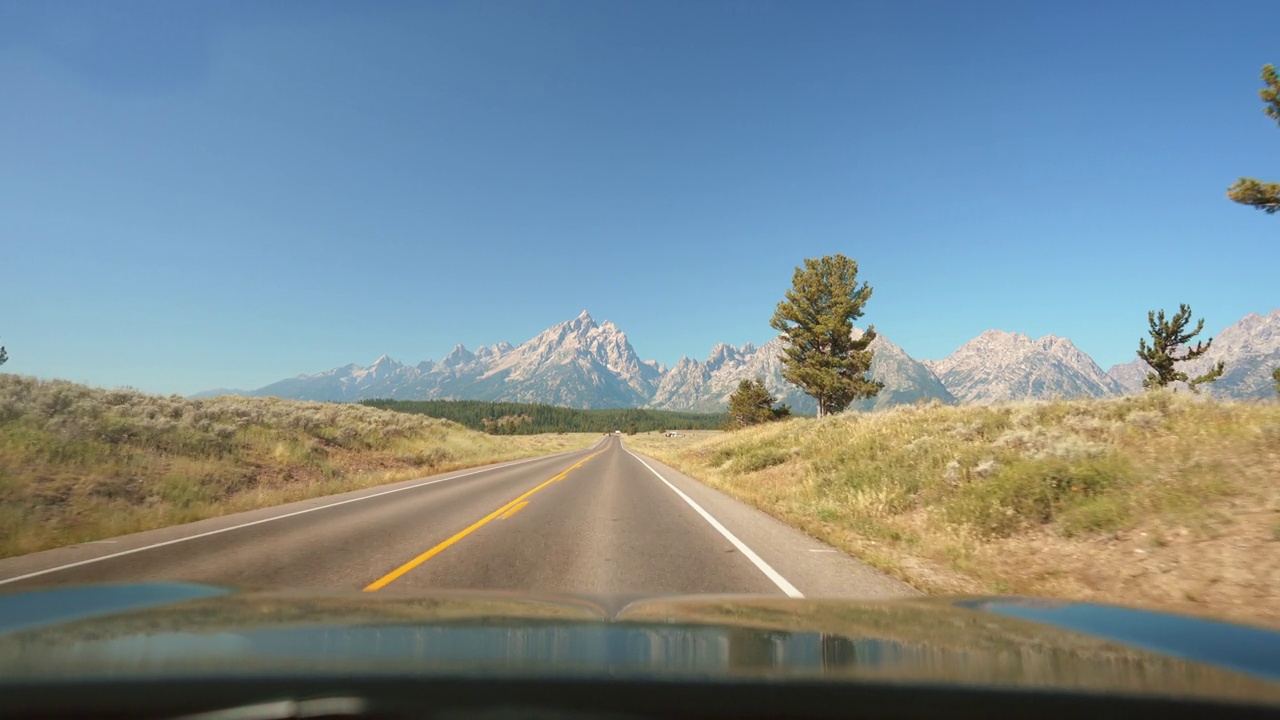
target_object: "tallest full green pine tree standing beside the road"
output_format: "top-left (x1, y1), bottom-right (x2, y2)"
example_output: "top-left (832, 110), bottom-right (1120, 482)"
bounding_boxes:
top-left (769, 254), bottom-right (883, 418)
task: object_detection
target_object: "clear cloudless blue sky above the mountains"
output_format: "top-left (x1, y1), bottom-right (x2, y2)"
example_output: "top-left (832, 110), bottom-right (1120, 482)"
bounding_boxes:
top-left (0, 0), bottom-right (1280, 393)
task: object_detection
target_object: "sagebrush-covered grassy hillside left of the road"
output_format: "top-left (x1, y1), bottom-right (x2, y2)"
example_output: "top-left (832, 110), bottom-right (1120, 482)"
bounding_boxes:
top-left (0, 374), bottom-right (596, 557)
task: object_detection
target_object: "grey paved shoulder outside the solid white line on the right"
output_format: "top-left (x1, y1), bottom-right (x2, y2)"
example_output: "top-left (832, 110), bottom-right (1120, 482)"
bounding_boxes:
top-left (627, 450), bottom-right (920, 598)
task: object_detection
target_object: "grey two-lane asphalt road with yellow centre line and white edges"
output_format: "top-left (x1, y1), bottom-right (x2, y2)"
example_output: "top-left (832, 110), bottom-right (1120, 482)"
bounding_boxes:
top-left (0, 437), bottom-right (914, 598)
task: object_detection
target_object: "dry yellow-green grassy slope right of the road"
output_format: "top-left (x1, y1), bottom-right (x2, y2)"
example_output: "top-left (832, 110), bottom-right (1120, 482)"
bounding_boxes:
top-left (628, 393), bottom-right (1280, 623)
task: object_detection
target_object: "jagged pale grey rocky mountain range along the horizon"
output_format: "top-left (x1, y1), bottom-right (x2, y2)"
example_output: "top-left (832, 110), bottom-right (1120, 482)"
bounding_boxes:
top-left (200, 309), bottom-right (1280, 414)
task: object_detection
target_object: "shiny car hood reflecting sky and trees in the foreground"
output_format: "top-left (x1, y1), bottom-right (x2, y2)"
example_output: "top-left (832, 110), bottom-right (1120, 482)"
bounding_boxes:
top-left (0, 583), bottom-right (1280, 706)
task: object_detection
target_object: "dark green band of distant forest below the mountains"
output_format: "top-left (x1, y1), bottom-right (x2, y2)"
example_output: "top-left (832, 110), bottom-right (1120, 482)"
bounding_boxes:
top-left (361, 398), bottom-right (728, 436)
